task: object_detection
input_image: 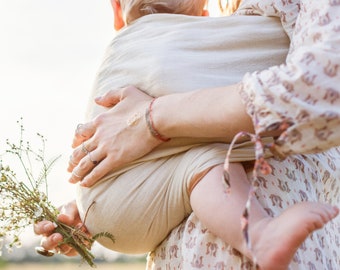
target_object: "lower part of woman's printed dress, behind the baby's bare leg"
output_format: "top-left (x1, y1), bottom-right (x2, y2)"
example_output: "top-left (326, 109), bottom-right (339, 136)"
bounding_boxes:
top-left (147, 149), bottom-right (340, 270)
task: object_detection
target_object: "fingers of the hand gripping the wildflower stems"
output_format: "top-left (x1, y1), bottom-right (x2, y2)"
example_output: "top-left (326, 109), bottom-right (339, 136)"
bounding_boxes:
top-left (33, 201), bottom-right (84, 256)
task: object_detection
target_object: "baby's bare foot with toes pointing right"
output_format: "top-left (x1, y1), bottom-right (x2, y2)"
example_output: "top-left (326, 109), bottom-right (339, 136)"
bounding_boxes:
top-left (249, 202), bottom-right (339, 270)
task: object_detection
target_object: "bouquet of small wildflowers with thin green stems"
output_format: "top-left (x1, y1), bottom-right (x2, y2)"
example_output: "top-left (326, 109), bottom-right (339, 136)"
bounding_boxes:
top-left (0, 125), bottom-right (114, 267)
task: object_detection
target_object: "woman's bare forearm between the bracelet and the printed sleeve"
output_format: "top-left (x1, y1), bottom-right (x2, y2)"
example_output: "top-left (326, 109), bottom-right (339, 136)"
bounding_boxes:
top-left (153, 85), bottom-right (254, 141)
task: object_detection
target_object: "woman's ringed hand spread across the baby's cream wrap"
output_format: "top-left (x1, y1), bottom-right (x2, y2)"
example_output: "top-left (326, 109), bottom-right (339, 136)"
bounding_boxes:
top-left (68, 86), bottom-right (162, 187)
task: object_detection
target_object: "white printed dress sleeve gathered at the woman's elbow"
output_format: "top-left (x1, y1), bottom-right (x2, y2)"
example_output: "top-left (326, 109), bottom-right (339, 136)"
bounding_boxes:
top-left (241, 0), bottom-right (340, 156)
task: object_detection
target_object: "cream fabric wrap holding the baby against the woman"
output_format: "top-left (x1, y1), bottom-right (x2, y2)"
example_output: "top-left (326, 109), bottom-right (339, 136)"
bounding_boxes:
top-left (77, 14), bottom-right (289, 253)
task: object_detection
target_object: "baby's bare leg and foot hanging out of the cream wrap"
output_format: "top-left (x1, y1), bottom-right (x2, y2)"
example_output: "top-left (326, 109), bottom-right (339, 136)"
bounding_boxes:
top-left (190, 163), bottom-right (338, 269)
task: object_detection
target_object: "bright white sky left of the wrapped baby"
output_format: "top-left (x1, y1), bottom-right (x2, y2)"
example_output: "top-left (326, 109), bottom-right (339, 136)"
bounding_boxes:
top-left (0, 0), bottom-right (220, 262)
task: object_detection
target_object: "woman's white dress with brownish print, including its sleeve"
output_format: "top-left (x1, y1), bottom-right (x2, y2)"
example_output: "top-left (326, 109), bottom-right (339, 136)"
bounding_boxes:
top-left (147, 0), bottom-right (340, 270)
